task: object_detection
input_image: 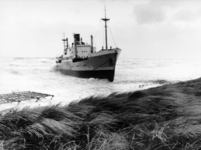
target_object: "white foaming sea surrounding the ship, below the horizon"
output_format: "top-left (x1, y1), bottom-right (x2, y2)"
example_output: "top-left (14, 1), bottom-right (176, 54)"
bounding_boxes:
top-left (0, 57), bottom-right (201, 110)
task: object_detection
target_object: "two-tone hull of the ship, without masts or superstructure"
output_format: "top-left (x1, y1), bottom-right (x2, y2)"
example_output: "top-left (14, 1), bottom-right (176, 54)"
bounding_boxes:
top-left (57, 50), bottom-right (120, 82)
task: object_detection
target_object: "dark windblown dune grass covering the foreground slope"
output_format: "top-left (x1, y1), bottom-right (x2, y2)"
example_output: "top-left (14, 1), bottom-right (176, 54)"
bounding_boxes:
top-left (0, 78), bottom-right (201, 150)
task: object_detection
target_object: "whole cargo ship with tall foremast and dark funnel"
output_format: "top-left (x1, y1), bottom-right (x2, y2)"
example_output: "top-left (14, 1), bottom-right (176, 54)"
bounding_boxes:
top-left (56, 13), bottom-right (121, 82)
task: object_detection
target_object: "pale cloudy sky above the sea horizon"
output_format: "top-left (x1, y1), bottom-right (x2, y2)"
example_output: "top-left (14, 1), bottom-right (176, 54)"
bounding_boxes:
top-left (0, 0), bottom-right (201, 59)
